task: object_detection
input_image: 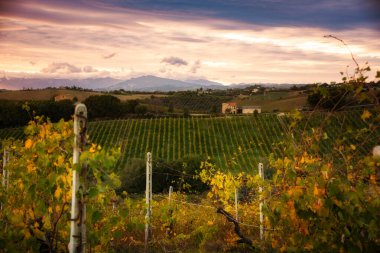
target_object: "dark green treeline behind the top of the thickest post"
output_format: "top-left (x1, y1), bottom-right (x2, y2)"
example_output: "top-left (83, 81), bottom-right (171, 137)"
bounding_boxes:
top-left (0, 95), bottom-right (147, 128)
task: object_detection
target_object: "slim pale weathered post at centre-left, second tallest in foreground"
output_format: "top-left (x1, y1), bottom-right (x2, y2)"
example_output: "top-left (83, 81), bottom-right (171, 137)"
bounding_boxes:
top-left (145, 152), bottom-right (152, 251)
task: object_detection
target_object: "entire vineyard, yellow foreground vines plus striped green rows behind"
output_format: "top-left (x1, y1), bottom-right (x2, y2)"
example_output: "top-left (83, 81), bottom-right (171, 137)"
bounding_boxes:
top-left (0, 107), bottom-right (380, 252)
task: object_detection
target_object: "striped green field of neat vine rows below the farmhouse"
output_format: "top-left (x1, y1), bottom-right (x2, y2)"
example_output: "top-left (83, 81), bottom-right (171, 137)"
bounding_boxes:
top-left (0, 111), bottom-right (380, 172)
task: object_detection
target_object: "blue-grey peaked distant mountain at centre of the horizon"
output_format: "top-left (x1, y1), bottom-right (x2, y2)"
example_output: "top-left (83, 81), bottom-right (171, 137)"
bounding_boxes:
top-left (107, 75), bottom-right (224, 92)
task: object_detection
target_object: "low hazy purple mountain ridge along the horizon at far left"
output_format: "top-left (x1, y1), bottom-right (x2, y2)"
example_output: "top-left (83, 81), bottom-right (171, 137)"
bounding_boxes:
top-left (0, 77), bottom-right (120, 90)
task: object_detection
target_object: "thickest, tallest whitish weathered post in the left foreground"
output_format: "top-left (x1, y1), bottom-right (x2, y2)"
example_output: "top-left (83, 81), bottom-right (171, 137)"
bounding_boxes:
top-left (69, 103), bottom-right (87, 253)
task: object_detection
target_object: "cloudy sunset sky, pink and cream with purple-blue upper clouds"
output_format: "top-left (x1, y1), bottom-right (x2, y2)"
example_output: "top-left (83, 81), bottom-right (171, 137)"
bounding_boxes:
top-left (0, 0), bottom-right (380, 84)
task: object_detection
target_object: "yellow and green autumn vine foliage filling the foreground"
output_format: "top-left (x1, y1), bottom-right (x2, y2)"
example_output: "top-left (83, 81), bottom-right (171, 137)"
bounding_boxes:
top-left (0, 107), bottom-right (380, 252)
